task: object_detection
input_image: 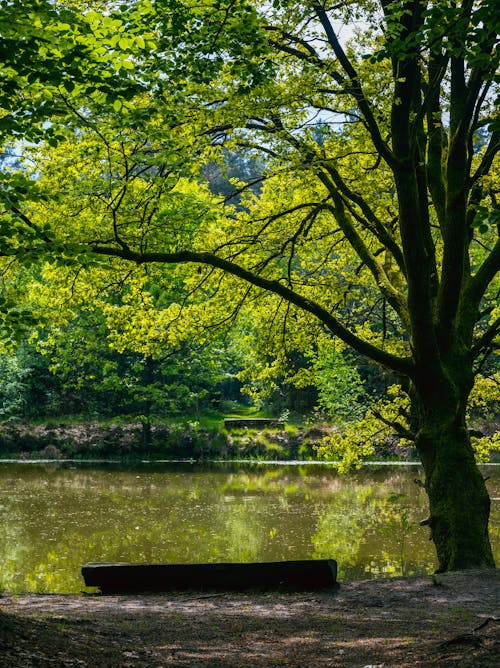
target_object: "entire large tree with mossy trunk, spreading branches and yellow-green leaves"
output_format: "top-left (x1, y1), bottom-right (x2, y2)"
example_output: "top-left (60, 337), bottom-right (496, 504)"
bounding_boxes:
top-left (4, 0), bottom-right (500, 571)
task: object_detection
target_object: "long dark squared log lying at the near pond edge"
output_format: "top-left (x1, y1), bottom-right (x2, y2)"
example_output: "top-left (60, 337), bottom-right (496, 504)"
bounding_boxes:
top-left (82, 559), bottom-right (337, 594)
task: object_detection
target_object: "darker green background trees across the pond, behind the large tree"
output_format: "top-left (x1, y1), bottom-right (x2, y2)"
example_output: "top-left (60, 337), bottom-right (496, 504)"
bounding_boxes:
top-left (0, 154), bottom-right (394, 425)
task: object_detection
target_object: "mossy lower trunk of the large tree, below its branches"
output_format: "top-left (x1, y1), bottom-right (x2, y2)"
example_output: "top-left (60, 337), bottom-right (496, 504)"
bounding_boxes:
top-left (416, 397), bottom-right (495, 572)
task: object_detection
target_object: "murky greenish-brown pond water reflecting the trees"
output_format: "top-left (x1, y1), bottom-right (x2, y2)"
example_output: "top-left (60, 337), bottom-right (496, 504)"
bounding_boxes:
top-left (0, 462), bottom-right (500, 593)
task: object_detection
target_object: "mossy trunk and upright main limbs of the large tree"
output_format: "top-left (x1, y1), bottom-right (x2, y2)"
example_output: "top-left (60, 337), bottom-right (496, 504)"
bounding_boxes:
top-left (384, 2), bottom-right (494, 572)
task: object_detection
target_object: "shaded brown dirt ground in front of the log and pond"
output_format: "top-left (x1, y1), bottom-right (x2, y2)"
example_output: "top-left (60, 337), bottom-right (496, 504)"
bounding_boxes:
top-left (0, 570), bottom-right (500, 668)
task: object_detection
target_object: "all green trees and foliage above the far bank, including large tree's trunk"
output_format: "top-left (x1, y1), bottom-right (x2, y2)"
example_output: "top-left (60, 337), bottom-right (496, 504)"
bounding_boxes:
top-left (0, 0), bottom-right (500, 570)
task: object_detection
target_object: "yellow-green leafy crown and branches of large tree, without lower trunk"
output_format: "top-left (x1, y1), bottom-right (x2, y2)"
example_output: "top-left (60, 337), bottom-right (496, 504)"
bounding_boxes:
top-left (3, 0), bottom-right (500, 454)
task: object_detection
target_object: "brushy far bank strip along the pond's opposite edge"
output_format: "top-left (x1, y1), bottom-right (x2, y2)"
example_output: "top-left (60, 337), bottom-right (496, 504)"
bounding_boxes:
top-left (0, 420), bottom-right (414, 460)
